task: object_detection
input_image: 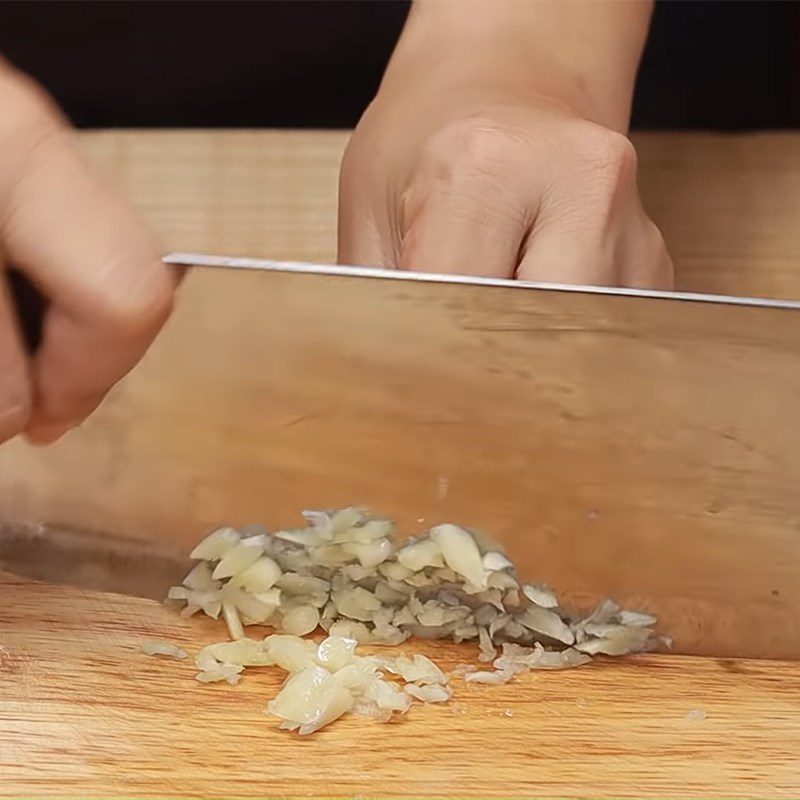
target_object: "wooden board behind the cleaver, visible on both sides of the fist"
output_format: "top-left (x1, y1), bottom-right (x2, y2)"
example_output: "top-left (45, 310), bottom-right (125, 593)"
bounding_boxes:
top-left (75, 131), bottom-right (800, 299)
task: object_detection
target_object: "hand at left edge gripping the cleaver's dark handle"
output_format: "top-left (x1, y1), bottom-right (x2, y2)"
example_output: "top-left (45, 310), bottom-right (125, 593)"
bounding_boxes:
top-left (0, 65), bottom-right (176, 443)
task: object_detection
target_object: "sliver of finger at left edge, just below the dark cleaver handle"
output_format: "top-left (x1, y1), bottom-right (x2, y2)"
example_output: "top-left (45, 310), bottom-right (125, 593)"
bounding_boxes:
top-left (0, 275), bottom-right (31, 443)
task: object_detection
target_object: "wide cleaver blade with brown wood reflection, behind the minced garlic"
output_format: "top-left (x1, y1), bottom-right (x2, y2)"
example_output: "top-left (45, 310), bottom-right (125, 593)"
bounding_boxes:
top-left (0, 253), bottom-right (800, 657)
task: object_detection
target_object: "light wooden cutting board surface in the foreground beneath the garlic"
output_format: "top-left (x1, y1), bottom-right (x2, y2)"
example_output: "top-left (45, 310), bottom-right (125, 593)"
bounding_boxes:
top-left (0, 577), bottom-right (800, 798)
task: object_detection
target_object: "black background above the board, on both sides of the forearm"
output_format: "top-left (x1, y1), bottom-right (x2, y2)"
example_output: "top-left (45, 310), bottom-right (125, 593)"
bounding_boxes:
top-left (0, 0), bottom-right (800, 129)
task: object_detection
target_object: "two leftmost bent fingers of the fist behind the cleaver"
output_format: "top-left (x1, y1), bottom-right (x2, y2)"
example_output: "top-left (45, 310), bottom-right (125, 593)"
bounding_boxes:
top-left (338, 112), bottom-right (535, 277)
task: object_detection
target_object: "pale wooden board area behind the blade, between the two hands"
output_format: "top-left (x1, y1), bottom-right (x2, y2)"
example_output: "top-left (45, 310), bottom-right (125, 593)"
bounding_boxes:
top-left (80, 131), bottom-right (347, 262)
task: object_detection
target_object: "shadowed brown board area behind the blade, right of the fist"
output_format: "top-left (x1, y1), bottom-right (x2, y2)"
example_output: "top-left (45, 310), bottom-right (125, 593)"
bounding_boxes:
top-left (634, 133), bottom-right (800, 299)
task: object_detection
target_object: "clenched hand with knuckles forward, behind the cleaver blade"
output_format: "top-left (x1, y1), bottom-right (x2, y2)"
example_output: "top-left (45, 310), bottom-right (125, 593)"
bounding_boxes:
top-left (339, 3), bottom-right (672, 289)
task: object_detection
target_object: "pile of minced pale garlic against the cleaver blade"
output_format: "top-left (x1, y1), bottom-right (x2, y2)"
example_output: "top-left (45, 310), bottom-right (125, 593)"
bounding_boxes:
top-left (147, 508), bottom-right (657, 734)
